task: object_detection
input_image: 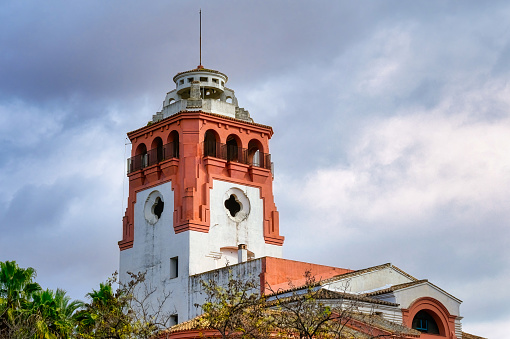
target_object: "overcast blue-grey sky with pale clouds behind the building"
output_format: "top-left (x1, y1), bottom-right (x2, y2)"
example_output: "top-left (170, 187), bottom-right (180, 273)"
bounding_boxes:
top-left (0, 0), bottom-right (510, 338)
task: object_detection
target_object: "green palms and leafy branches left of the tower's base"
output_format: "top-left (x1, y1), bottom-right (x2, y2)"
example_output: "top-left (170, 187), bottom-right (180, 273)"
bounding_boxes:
top-left (0, 261), bottom-right (170, 339)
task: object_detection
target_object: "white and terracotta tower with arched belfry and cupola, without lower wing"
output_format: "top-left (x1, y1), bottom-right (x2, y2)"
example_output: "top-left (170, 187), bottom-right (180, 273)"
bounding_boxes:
top-left (119, 66), bottom-right (284, 322)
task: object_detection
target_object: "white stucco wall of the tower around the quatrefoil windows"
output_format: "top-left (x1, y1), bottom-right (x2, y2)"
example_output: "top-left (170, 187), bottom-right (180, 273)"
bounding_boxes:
top-left (120, 180), bottom-right (282, 322)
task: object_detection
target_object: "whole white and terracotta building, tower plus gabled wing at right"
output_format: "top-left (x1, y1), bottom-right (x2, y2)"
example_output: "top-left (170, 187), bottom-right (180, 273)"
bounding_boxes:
top-left (119, 66), bottom-right (482, 338)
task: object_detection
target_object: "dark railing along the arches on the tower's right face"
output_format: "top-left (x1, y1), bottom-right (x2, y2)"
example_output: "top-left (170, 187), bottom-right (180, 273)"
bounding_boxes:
top-left (204, 141), bottom-right (272, 170)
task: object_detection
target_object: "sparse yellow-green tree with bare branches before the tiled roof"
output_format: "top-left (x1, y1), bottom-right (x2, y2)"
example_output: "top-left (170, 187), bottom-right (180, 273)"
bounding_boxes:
top-left (196, 271), bottom-right (364, 339)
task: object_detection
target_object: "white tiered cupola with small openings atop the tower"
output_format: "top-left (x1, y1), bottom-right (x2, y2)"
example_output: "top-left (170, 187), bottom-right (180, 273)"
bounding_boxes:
top-left (152, 65), bottom-right (253, 122)
